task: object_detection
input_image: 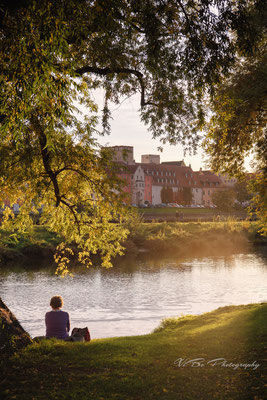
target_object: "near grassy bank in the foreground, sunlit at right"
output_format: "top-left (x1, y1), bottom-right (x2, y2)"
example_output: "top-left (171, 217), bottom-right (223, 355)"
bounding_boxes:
top-left (1, 304), bottom-right (267, 400)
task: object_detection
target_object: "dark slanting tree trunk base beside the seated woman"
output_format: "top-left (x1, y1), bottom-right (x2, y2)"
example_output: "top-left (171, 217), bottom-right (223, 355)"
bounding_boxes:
top-left (0, 298), bottom-right (32, 359)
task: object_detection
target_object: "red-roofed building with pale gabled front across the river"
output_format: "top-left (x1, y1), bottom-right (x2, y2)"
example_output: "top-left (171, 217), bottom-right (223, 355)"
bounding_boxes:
top-left (110, 146), bottom-right (225, 206)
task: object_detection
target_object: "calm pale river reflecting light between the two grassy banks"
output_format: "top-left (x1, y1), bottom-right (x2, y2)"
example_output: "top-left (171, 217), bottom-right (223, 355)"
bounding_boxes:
top-left (0, 253), bottom-right (267, 338)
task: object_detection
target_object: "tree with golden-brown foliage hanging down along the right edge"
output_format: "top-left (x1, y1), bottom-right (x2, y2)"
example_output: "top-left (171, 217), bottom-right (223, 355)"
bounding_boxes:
top-left (204, 1), bottom-right (267, 234)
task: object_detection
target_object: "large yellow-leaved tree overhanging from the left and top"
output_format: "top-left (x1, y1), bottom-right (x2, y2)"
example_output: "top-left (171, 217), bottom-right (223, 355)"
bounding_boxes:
top-left (0, 0), bottom-right (264, 270)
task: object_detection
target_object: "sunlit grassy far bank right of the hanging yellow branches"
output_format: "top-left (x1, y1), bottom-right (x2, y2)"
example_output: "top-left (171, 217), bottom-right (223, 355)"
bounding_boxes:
top-left (125, 218), bottom-right (262, 255)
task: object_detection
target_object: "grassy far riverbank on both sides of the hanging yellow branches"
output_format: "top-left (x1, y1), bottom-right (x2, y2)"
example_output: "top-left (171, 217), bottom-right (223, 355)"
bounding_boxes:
top-left (0, 219), bottom-right (267, 267)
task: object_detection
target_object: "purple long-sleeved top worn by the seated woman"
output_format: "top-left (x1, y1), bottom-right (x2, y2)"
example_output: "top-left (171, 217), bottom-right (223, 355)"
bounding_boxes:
top-left (45, 310), bottom-right (70, 339)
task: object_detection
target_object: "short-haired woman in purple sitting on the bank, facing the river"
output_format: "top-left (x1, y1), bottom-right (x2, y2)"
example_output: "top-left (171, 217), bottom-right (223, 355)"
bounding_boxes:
top-left (45, 296), bottom-right (70, 340)
